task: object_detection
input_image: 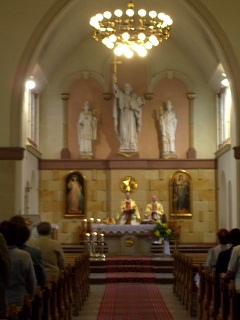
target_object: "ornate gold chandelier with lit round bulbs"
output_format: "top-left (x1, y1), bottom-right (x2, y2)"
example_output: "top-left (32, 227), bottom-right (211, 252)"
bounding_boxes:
top-left (90, 1), bottom-right (173, 58)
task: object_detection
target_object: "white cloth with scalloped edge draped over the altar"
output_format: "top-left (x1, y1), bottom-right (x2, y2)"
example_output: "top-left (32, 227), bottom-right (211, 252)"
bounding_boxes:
top-left (92, 223), bottom-right (155, 234)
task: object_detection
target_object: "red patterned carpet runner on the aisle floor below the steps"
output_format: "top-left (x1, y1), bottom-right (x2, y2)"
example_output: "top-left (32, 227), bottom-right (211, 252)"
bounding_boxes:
top-left (97, 283), bottom-right (173, 320)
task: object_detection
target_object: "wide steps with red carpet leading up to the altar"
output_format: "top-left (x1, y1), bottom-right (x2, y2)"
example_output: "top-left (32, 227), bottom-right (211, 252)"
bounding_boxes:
top-left (90, 255), bottom-right (174, 284)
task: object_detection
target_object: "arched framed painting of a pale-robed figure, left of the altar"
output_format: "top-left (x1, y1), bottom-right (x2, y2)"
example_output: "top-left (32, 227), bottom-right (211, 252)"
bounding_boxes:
top-left (64, 171), bottom-right (86, 217)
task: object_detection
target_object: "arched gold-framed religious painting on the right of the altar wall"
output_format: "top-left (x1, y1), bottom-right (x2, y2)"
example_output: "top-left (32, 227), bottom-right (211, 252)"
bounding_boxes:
top-left (170, 170), bottom-right (192, 218)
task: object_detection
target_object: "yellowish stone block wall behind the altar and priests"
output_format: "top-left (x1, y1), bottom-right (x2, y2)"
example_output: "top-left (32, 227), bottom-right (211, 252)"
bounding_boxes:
top-left (39, 169), bottom-right (217, 243)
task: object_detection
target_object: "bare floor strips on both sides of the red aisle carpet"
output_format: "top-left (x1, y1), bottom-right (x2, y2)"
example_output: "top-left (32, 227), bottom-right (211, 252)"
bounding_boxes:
top-left (73, 284), bottom-right (194, 320)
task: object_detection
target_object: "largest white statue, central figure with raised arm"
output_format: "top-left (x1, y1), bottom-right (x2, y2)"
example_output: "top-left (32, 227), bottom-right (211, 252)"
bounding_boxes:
top-left (113, 77), bottom-right (145, 152)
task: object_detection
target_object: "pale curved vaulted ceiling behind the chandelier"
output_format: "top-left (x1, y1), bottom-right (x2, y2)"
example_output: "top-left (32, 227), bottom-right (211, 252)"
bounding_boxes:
top-left (31, 0), bottom-right (227, 89)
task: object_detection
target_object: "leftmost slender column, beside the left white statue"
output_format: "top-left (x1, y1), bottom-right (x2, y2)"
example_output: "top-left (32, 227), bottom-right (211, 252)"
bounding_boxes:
top-left (61, 93), bottom-right (70, 159)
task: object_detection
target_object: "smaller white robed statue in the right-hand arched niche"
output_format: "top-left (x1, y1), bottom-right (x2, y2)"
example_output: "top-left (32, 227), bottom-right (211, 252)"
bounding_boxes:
top-left (159, 100), bottom-right (177, 157)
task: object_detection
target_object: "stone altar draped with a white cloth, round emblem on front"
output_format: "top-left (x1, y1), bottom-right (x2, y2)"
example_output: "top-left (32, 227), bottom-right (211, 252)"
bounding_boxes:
top-left (92, 224), bottom-right (154, 255)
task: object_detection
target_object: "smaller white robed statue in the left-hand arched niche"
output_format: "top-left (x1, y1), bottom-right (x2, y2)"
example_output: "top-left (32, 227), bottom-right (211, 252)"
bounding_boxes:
top-left (78, 101), bottom-right (97, 155)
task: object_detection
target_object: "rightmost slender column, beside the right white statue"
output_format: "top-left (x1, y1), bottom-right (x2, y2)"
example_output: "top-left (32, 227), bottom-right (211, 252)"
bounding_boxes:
top-left (187, 92), bottom-right (196, 159)
